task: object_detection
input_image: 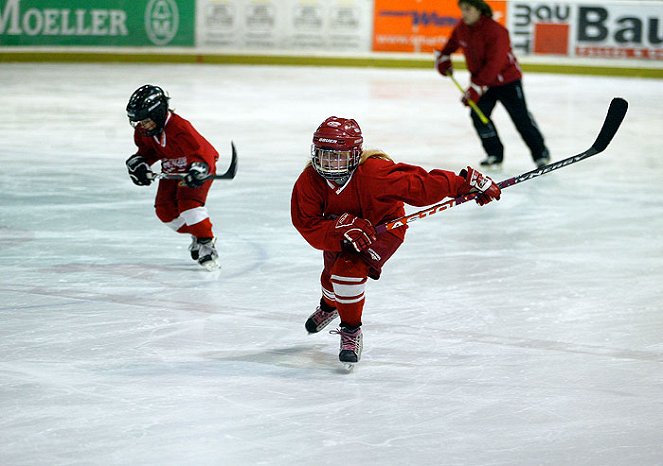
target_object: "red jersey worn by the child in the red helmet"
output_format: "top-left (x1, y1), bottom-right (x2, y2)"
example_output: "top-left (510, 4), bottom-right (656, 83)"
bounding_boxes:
top-left (290, 157), bottom-right (467, 251)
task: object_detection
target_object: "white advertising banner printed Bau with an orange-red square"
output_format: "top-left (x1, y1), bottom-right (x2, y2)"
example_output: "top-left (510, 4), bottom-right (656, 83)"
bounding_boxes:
top-left (508, 1), bottom-right (663, 60)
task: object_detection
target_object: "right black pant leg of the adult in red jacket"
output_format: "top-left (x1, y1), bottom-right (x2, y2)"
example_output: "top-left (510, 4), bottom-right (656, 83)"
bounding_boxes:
top-left (493, 80), bottom-right (548, 160)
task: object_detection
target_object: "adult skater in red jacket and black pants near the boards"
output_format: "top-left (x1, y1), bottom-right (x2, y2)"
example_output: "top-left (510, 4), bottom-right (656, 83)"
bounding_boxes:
top-left (435, 0), bottom-right (550, 167)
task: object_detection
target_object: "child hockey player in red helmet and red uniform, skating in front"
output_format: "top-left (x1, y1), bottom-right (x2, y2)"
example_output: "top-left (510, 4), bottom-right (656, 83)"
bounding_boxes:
top-left (291, 117), bottom-right (500, 364)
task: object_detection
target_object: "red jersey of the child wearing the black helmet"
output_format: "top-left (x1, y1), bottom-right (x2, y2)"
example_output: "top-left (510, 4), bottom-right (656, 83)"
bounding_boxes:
top-left (134, 112), bottom-right (219, 173)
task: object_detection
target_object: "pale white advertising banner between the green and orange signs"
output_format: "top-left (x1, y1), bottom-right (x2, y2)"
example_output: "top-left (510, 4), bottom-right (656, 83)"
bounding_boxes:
top-left (198, 0), bottom-right (372, 52)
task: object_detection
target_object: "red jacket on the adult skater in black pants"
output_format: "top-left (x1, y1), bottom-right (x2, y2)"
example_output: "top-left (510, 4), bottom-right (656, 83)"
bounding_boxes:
top-left (442, 16), bottom-right (522, 87)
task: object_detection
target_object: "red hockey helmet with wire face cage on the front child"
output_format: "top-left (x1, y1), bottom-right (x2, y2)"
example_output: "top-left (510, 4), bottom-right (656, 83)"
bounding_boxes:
top-left (311, 116), bottom-right (364, 182)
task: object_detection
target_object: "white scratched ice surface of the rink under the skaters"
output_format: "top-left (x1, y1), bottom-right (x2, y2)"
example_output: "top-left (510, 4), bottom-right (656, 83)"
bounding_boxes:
top-left (0, 64), bottom-right (663, 465)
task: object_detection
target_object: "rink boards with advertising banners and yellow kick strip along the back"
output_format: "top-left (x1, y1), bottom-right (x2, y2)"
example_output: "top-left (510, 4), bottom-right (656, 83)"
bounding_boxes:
top-left (0, 0), bottom-right (663, 77)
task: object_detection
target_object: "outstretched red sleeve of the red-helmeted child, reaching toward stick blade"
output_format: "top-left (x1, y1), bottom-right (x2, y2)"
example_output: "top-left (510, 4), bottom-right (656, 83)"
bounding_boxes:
top-left (364, 159), bottom-right (468, 207)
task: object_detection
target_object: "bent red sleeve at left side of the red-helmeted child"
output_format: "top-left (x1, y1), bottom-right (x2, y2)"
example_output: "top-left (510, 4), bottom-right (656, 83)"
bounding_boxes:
top-left (290, 166), bottom-right (341, 251)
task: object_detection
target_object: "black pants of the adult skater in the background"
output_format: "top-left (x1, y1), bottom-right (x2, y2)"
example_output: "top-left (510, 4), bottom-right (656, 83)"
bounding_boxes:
top-left (470, 80), bottom-right (548, 161)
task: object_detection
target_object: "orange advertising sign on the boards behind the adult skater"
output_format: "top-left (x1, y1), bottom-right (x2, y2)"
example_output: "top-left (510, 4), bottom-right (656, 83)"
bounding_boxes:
top-left (373, 0), bottom-right (506, 53)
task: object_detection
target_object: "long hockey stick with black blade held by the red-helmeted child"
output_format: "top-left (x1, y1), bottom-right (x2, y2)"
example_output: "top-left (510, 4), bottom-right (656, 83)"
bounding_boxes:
top-left (375, 97), bottom-right (628, 234)
